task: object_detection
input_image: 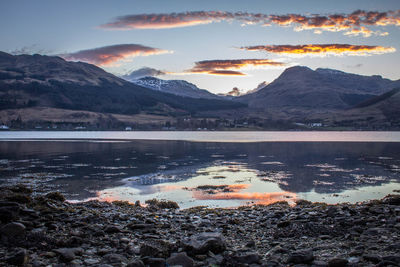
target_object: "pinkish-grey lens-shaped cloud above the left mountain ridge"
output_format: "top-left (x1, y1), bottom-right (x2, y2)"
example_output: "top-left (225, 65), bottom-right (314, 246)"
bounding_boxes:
top-left (60, 44), bottom-right (170, 66)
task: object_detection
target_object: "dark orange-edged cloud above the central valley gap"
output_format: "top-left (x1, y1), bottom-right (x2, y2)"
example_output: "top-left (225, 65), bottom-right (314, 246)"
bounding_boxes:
top-left (186, 59), bottom-right (286, 76)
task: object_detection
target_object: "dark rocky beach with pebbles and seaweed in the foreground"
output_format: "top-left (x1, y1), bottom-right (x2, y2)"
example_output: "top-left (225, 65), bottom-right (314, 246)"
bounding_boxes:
top-left (0, 186), bottom-right (400, 267)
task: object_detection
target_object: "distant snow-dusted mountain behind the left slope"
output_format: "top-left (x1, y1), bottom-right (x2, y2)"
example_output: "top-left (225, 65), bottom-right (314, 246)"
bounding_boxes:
top-left (123, 76), bottom-right (222, 99)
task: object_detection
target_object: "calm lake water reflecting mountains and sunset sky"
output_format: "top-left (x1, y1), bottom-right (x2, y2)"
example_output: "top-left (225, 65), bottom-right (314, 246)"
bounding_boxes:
top-left (0, 132), bottom-right (400, 208)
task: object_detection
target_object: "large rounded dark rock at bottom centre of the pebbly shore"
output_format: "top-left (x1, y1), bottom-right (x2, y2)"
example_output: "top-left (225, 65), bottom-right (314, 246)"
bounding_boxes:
top-left (184, 232), bottom-right (226, 255)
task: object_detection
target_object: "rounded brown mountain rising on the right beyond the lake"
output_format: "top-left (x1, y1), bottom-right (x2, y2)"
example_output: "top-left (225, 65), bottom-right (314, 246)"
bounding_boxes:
top-left (237, 66), bottom-right (400, 111)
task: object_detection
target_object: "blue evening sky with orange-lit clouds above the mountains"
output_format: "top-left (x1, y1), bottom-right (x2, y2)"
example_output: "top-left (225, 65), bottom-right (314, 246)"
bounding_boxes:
top-left (0, 0), bottom-right (400, 93)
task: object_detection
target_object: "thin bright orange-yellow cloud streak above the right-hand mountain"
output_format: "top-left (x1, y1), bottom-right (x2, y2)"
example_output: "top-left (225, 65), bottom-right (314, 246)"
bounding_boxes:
top-left (241, 44), bottom-right (396, 56)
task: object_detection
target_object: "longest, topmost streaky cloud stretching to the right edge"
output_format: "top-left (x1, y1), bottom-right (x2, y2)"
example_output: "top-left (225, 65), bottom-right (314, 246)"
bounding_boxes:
top-left (100, 10), bottom-right (400, 37)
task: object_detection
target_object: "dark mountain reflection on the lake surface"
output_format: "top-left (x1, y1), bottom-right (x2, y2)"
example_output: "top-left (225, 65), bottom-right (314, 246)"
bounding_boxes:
top-left (0, 141), bottom-right (400, 198)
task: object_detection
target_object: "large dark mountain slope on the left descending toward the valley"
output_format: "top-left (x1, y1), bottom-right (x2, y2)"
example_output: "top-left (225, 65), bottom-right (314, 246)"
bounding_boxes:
top-left (0, 52), bottom-right (244, 115)
